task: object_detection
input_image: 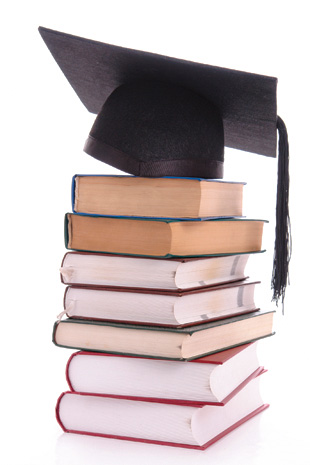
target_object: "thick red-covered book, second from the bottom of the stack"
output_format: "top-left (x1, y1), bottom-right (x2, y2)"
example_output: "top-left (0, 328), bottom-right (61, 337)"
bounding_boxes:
top-left (66, 342), bottom-right (264, 405)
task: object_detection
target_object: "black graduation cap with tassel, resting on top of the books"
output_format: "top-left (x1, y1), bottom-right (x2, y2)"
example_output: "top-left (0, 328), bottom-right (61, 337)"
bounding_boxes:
top-left (39, 27), bottom-right (291, 303)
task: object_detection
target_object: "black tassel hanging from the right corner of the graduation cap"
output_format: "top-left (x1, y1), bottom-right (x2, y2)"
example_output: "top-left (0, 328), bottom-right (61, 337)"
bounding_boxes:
top-left (271, 116), bottom-right (292, 313)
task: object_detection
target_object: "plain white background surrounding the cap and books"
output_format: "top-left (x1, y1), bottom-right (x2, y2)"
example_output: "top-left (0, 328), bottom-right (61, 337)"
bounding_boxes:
top-left (1, 0), bottom-right (309, 465)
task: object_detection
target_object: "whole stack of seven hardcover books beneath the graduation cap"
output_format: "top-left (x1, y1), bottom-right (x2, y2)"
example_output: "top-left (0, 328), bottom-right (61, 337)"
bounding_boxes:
top-left (53, 175), bottom-right (273, 449)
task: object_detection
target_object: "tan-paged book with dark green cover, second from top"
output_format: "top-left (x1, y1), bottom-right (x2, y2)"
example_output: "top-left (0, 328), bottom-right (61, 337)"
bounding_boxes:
top-left (65, 213), bottom-right (264, 257)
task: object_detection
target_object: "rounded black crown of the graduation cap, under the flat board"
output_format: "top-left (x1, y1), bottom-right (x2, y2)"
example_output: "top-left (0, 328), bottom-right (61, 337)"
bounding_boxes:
top-left (84, 81), bottom-right (224, 178)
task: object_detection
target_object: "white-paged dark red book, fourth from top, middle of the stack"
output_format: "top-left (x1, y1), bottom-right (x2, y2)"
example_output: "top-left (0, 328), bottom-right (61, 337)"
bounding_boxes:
top-left (59, 280), bottom-right (258, 327)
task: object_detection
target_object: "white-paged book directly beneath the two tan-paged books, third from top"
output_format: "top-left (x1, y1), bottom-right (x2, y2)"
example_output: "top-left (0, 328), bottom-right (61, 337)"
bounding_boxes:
top-left (60, 252), bottom-right (249, 290)
